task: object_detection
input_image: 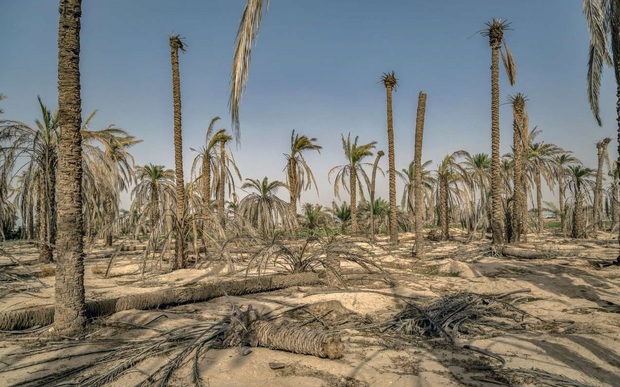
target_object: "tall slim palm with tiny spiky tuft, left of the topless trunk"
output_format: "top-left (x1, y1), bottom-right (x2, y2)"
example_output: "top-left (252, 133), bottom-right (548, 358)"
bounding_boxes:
top-left (381, 71), bottom-right (398, 244)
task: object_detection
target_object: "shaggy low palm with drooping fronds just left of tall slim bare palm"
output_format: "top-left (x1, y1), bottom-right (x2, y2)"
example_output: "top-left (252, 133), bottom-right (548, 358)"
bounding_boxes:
top-left (130, 164), bottom-right (175, 235)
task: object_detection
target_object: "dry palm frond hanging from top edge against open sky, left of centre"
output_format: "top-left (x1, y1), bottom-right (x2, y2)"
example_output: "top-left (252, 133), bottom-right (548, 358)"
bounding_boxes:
top-left (228, 0), bottom-right (269, 141)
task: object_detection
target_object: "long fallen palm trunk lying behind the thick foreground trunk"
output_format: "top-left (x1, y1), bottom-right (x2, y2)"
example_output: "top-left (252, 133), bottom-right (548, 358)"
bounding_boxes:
top-left (0, 273), bottom-right (321, 331)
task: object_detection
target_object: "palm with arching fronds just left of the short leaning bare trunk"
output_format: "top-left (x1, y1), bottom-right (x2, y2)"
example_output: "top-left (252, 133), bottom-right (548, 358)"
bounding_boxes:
top-left (327, 133), bottom-right (377, 234)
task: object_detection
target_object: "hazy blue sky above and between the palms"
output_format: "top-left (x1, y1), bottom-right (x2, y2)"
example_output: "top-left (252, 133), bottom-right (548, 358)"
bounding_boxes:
top-left (0, 0), bottom-right (616, 209)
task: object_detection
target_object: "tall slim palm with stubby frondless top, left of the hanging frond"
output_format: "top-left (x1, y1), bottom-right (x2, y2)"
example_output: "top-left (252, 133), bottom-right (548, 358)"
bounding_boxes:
top-left (170, 35), bottom-right (187, 269)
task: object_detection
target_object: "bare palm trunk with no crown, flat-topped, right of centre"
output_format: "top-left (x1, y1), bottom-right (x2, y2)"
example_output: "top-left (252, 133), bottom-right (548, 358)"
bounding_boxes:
top-left (413, 92), bottom-right (426, 259)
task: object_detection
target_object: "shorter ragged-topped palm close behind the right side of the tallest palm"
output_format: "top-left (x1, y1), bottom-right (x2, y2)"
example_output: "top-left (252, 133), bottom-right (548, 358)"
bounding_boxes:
top-left (509, 93), bottom-right (529, 242)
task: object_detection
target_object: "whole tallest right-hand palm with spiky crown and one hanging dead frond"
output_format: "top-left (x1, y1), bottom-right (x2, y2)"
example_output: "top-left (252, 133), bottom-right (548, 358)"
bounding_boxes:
top-left (482, 19), bottom-right (517, 244)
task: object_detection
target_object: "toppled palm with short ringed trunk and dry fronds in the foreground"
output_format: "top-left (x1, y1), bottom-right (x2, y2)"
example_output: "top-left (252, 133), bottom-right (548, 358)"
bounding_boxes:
top-left (0, 305), bottom-right (344, 386)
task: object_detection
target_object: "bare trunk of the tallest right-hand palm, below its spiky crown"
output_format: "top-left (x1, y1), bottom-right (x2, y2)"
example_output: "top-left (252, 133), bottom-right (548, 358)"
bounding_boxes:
top-left (491, 42), bottom-right (503, 244)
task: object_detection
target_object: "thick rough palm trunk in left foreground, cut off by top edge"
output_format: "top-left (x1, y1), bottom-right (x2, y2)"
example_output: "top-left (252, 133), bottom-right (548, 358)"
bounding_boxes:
top-left (54, 0), bottom-right (86, 336)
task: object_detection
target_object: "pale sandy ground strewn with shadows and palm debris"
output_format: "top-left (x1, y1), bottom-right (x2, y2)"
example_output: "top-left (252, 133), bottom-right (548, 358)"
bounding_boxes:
top-left (0, 232), bottom-right (620, 387)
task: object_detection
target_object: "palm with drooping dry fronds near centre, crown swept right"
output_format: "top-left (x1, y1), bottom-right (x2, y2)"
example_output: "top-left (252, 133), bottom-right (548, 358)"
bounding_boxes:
top-left (284, 129), bottom-right (322, 224)
